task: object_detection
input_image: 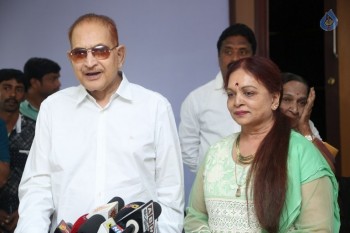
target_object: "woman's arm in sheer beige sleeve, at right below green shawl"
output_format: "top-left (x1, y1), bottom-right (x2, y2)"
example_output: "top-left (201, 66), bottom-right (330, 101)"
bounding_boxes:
top-left (294, 176), bottom-right (335, 233)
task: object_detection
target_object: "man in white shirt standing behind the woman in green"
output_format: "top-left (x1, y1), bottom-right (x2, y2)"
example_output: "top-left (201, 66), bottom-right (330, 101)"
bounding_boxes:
top-left (179, 24), bottom-right (256, 172)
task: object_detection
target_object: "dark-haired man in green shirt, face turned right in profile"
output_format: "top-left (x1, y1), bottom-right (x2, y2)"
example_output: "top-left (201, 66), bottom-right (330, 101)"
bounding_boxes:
top-left (20, 57), bottom-right (61, 120)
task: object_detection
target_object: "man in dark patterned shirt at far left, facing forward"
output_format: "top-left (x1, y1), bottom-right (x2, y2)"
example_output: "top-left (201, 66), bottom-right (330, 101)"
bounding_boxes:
top-left (0, 69), bottom-right (35, 233)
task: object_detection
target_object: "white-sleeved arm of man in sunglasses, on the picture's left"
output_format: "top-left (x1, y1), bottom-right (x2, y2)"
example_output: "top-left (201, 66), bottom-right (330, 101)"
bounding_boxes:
top-left (15, 106), bottom-right (54, 233)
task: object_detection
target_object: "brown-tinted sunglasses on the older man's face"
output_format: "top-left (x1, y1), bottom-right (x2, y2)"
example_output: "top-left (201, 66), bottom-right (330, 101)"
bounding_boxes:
top-left (68, 45), bottom-right (118, 62)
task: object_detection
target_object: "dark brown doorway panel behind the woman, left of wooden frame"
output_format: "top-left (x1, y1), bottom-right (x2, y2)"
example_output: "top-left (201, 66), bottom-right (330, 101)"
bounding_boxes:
top-left (269, 0), bottom-right (327, 138)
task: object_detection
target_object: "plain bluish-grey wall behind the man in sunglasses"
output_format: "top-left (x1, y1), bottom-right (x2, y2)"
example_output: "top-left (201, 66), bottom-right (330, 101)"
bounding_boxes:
top-left (0, 0), bottom-right (229, 204)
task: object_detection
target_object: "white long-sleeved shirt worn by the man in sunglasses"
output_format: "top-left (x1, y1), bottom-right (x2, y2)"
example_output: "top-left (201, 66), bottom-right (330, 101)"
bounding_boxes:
top-left (15, 75), bottom-right (184, 233)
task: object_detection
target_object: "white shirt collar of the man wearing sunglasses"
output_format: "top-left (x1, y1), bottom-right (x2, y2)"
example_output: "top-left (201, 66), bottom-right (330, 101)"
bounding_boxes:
top-left (77, 73), bottom-right (134, 105)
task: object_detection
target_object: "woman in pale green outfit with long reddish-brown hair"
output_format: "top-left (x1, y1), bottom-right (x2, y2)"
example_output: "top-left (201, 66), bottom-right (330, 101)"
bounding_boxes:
top-left (185, 56), bottom-right (340, 233)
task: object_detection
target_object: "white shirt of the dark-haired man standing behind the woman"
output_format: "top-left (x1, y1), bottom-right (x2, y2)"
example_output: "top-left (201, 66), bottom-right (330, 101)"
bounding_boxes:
top-left (179, 72), bottom-right (241, 172)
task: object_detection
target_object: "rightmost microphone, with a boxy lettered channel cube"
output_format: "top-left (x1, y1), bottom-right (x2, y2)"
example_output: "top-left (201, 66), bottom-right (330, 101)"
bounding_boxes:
top-left (115, 200), bottom-right (162, 233)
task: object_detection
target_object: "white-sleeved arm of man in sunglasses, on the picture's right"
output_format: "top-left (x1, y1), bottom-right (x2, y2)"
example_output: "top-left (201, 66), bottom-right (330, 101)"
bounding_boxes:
top-left (155, 103), bottom-right (184, 233)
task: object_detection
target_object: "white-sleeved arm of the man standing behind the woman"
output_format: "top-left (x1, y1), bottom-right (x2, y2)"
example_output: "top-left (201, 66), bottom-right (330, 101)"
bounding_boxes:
top-left (179, 96), bottom-right (200, 172)
